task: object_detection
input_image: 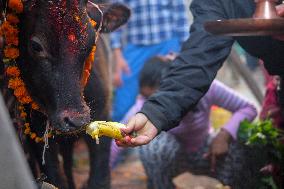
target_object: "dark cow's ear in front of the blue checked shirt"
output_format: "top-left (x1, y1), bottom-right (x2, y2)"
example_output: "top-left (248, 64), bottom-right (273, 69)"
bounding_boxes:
top-left (87, 1), bottom-right (130, 33)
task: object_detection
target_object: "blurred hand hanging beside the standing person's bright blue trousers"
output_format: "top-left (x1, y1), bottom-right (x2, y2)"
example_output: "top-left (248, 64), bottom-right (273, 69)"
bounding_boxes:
top-left (113, 50), bottom-right (130, 87)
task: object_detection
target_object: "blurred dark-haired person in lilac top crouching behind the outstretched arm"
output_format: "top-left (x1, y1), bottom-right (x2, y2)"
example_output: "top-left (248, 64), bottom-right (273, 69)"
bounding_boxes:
top-left (111, 55), bottom-right (257, 189)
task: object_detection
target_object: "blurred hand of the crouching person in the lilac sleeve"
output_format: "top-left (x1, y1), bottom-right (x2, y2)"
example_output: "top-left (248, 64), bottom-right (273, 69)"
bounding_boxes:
top-left (204, 129), bottom-right (231, 172)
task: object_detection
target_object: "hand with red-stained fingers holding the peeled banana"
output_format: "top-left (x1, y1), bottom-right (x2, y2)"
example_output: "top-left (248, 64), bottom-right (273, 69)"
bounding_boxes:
top-left (116, 113), bottom-right (158, 147)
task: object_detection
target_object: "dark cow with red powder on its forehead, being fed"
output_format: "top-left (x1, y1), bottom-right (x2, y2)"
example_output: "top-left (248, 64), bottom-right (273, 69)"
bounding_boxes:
top-left (1, 0), bottom-right (130, 188)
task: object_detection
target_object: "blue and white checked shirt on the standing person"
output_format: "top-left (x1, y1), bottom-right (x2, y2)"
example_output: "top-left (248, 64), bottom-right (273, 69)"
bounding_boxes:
top-left (110, 0), bottom-right (189, 48)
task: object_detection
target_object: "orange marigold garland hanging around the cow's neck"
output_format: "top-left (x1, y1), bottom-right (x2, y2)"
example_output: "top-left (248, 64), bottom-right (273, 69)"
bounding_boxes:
top-left (0, 0), bottom-right (96, 143)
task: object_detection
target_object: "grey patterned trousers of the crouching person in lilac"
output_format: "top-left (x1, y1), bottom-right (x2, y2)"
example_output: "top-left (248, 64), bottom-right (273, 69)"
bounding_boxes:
top-left (139, 132), bottom-right (265, 189)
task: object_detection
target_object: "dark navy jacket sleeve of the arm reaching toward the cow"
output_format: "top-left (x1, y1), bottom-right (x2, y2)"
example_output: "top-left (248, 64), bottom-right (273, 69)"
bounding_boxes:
top-left (141, 0), bottom-right (233, 131)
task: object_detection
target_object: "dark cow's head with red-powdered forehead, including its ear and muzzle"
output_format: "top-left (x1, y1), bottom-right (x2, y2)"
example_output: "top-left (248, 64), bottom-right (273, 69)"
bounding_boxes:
top-left (18, 0), bottom-right (130, 133)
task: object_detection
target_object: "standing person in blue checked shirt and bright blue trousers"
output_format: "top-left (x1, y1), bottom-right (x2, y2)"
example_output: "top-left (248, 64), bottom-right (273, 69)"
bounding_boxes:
top-left (110, 0), bottom-right (189, 121)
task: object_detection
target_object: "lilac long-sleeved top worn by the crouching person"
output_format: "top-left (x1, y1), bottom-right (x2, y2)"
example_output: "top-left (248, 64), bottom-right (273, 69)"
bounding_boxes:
top-left (121, 80), bottom-right (257, 152)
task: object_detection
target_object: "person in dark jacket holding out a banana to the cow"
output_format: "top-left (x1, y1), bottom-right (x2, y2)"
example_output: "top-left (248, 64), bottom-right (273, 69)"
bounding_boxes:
top-left (117, 0), bottom-right (284, 151)
